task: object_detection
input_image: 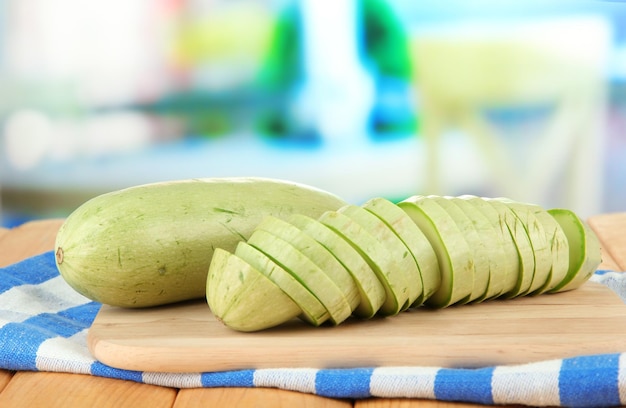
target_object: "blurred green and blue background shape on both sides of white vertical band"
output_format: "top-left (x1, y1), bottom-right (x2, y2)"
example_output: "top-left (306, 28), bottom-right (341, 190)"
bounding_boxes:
top-left (251, 0), bottom-right (417, 142)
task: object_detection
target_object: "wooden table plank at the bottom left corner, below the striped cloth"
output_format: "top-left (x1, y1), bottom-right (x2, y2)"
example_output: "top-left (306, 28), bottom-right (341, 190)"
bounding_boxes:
top-left (0, 372), bottom-right (176, 408)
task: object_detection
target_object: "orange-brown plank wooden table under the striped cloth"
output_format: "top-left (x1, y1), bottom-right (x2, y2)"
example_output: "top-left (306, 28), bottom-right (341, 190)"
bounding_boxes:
top-left (0, 212), bottom-right (626, 408)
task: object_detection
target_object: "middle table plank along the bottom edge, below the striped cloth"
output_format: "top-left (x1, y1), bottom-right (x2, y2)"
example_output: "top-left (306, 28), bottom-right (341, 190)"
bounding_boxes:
top-left (174, 388), bottom-right (352, 408)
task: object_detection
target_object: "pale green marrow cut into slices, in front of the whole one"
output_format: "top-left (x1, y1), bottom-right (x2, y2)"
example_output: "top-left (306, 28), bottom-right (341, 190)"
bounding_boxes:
top-left (206, 195), bottom-right (601, 331)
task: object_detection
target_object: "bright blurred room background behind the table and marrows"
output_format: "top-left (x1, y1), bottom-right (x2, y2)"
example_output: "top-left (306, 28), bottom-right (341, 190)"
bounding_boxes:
top-left (0, 0), bottom-right (626, 227)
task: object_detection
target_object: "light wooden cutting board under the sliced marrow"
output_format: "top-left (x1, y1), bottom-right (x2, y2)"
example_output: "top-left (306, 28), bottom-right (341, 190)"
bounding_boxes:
top-left (88, 282), bottom-right (626, 372)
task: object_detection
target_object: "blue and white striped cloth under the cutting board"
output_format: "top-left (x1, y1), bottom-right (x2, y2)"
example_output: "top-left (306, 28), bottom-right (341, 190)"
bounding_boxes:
top-left (0, 252), bottom-right (626, 407)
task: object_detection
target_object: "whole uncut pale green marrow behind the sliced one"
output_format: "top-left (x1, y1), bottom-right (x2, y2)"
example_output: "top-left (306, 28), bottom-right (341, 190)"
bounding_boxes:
top-left (55, 177), bottom-right (346, 308)
